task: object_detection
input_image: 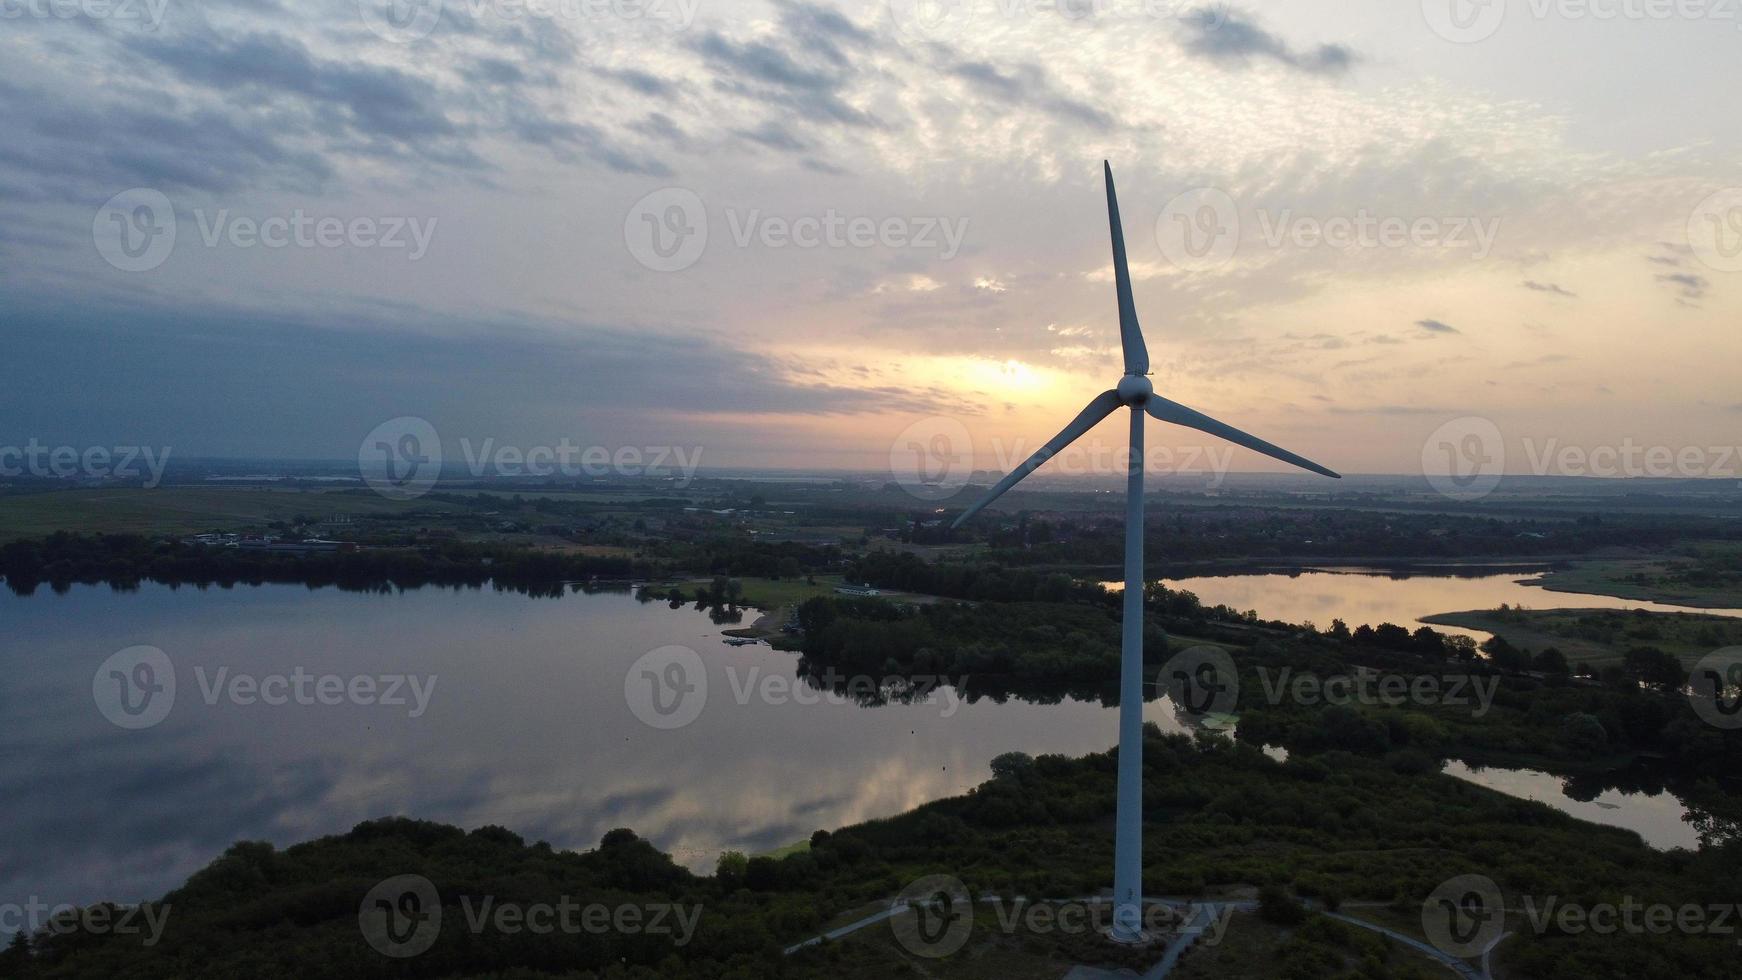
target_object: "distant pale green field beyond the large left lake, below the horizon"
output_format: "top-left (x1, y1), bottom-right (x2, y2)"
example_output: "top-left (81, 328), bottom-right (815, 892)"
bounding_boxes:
top-left (0, 487), bottom-right (463, 541)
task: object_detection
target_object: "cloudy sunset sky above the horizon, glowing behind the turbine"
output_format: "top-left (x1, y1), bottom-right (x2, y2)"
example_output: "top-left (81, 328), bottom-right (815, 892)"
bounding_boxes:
top-left (0, 0), bottom-right (1742, 477)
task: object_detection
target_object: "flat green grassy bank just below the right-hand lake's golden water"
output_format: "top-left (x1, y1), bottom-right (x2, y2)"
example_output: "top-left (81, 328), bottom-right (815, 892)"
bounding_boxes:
top-left (1421, 609), bottom-right (1742, 667)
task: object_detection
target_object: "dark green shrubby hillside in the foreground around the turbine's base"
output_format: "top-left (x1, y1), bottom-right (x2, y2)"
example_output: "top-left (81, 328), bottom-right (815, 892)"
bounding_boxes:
top-left (10, 741), bottom-right (1742, 980)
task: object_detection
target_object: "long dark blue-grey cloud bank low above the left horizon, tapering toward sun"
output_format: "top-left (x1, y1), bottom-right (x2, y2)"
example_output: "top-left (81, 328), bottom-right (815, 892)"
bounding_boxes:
top-left (0, 294), bottom-right (956, 458)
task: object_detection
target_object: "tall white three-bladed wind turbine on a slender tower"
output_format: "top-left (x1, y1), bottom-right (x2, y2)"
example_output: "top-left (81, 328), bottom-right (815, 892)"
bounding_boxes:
top-left (951, 162), bottom-right (1341, 943)
